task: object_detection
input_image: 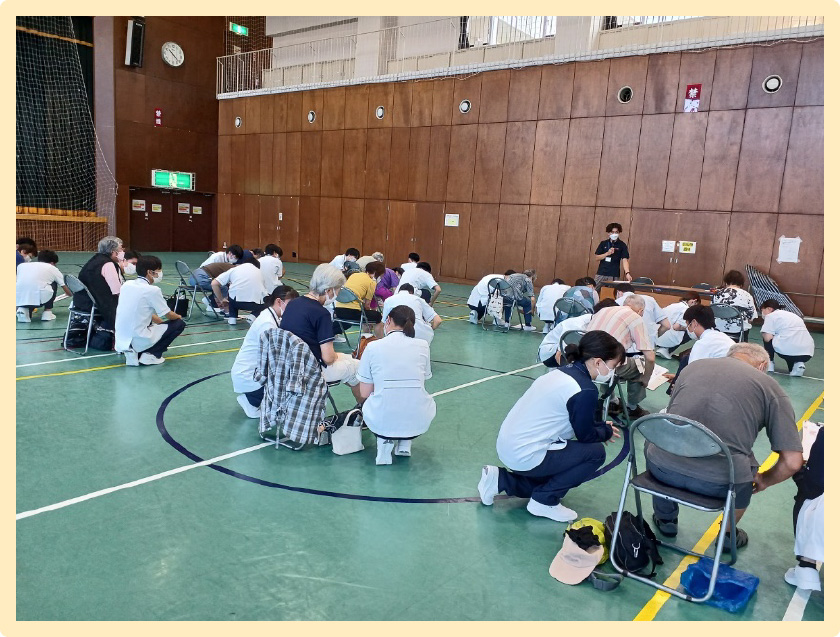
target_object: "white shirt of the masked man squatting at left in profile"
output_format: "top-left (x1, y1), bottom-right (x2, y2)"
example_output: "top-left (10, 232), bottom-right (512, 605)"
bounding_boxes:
top-left (114, 277), bottom-right (169, 352)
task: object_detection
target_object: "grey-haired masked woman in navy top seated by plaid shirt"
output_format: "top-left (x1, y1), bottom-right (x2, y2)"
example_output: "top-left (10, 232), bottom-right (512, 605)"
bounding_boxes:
top-left (280, 263), bottom-right (364, 403)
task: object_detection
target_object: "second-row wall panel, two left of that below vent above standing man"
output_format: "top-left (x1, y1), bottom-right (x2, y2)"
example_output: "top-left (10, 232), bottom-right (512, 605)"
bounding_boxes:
top-left (531, 119), bottom-right (569, 205)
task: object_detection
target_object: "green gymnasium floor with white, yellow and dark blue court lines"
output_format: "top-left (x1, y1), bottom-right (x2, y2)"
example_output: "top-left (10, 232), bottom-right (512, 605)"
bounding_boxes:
top-left (16, 253), bottom-right (824, 621)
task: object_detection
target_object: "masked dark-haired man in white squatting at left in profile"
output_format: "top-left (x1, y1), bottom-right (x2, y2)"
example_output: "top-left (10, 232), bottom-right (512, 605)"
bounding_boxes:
top-left (114, 256), bottom-right (186, 367)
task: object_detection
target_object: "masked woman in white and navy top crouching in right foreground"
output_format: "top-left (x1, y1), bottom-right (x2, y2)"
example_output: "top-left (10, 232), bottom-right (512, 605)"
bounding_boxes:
top-left (478, 330), bottom-right (624, 522)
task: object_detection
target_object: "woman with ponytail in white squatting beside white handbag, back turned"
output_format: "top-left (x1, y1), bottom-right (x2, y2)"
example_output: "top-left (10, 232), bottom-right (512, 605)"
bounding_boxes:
top-left (356, 305), bottom-right (437, 464)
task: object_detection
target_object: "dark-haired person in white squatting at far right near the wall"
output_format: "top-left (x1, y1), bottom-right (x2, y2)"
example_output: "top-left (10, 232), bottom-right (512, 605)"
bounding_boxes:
top-left (761, 299), bottom-right (814, 376)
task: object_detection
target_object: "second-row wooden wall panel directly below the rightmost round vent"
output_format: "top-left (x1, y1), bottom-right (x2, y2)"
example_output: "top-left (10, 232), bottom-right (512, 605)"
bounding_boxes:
top-left (732, 108), bottom-right (793, 212)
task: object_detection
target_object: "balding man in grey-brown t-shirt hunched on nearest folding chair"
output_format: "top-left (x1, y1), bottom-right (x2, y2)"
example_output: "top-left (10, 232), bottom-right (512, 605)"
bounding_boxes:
top-left (645, 342), bottom-right (803, 551)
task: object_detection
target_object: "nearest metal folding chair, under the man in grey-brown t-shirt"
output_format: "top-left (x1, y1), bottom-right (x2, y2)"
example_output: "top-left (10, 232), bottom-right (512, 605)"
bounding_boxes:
top-left (610, 414), bottom-right (737, 602)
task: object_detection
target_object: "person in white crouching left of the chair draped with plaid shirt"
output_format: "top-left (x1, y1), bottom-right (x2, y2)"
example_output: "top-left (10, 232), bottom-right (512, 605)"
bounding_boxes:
top-left (230, 285), bottom-right (300, 418)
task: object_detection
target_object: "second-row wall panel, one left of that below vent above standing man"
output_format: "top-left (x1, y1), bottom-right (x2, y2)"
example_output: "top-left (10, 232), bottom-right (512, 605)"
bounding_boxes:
top-left (562, 117), bottom-right (604, 206)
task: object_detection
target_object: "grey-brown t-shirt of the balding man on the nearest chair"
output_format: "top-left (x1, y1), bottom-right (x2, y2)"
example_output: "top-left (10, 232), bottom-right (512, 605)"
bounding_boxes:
top-left (645, 357), bottom-right (802, 484)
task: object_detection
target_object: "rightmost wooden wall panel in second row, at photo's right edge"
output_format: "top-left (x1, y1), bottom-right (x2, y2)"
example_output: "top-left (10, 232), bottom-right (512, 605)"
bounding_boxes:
top-left (779, 106), bottom-right (825, 215)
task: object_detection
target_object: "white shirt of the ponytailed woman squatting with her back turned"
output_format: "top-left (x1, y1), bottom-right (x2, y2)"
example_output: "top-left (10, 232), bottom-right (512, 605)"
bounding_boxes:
top-left (356, 331), bottom-right (437, 438)
